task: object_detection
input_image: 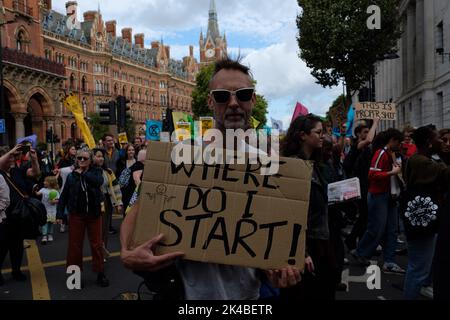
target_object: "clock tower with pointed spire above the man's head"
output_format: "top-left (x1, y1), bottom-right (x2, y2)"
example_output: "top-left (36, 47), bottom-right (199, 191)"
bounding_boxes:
top-left (199, 0), bottom-right (227, 65)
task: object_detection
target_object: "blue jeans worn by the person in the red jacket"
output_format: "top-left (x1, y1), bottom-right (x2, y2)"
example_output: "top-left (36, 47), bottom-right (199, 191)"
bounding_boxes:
top-left (356, 192), bottom-right (398, 263)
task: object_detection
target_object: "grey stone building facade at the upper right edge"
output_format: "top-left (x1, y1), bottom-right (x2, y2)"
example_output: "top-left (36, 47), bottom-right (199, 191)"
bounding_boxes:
top-left (375, 0), bottom-right (450, 129)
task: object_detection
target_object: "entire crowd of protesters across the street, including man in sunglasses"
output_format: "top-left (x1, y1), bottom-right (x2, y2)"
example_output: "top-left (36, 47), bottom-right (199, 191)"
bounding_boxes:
top-left (0, 60), bottom-right (450, 300)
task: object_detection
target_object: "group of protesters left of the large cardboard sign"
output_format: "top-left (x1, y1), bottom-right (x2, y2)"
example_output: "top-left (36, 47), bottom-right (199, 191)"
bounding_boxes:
top-left (0, 134), bottom-right (146, 287)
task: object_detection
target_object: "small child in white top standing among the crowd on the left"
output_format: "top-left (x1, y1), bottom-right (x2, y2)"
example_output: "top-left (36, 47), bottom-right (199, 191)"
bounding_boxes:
top-left (36, 176), bottom-right (59, 245)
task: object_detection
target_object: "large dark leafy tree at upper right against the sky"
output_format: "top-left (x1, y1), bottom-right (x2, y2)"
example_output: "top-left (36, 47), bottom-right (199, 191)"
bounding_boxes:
top-left (297, 0), bottom-right (401, 107)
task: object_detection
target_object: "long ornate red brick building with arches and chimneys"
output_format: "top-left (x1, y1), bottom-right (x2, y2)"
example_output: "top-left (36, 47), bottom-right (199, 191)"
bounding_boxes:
top-left (0, 0), bottom-right (198, 144)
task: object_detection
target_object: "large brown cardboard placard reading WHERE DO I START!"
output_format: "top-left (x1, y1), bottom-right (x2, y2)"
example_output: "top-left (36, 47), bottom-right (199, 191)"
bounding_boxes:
top-left (132, 141), bottom-right (312, 269)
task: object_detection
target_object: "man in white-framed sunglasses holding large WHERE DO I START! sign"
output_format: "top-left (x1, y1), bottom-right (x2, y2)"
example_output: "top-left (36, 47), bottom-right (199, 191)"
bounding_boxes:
top-left (121, 60), bottom-right (311, 300)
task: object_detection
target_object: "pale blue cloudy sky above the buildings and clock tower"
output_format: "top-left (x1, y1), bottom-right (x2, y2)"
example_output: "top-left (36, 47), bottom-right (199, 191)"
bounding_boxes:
top-left (53, 0), bottom-right (342, 129)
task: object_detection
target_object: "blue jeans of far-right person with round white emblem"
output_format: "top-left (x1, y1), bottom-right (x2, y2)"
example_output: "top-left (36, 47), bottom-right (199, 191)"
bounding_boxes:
top-left (403, 234), bottom-right (436, 300)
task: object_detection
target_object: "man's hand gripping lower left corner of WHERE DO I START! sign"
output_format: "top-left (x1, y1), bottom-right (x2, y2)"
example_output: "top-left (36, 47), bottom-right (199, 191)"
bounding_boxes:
top-left (120, 234), bottom-right (184, 271)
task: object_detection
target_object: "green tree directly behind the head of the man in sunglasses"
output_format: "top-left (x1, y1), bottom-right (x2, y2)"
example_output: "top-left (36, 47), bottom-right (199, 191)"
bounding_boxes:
top-left (192, 64), bottom-right (268, 126)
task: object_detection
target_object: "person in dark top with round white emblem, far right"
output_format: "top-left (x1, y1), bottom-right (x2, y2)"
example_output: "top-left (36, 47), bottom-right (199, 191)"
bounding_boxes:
top-left (401, 125), bottom-right (450, 300)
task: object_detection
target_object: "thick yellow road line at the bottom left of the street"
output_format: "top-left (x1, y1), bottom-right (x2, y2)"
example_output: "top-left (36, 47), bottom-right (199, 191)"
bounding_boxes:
top-left (26, 240), bottom-right (50, 300)
